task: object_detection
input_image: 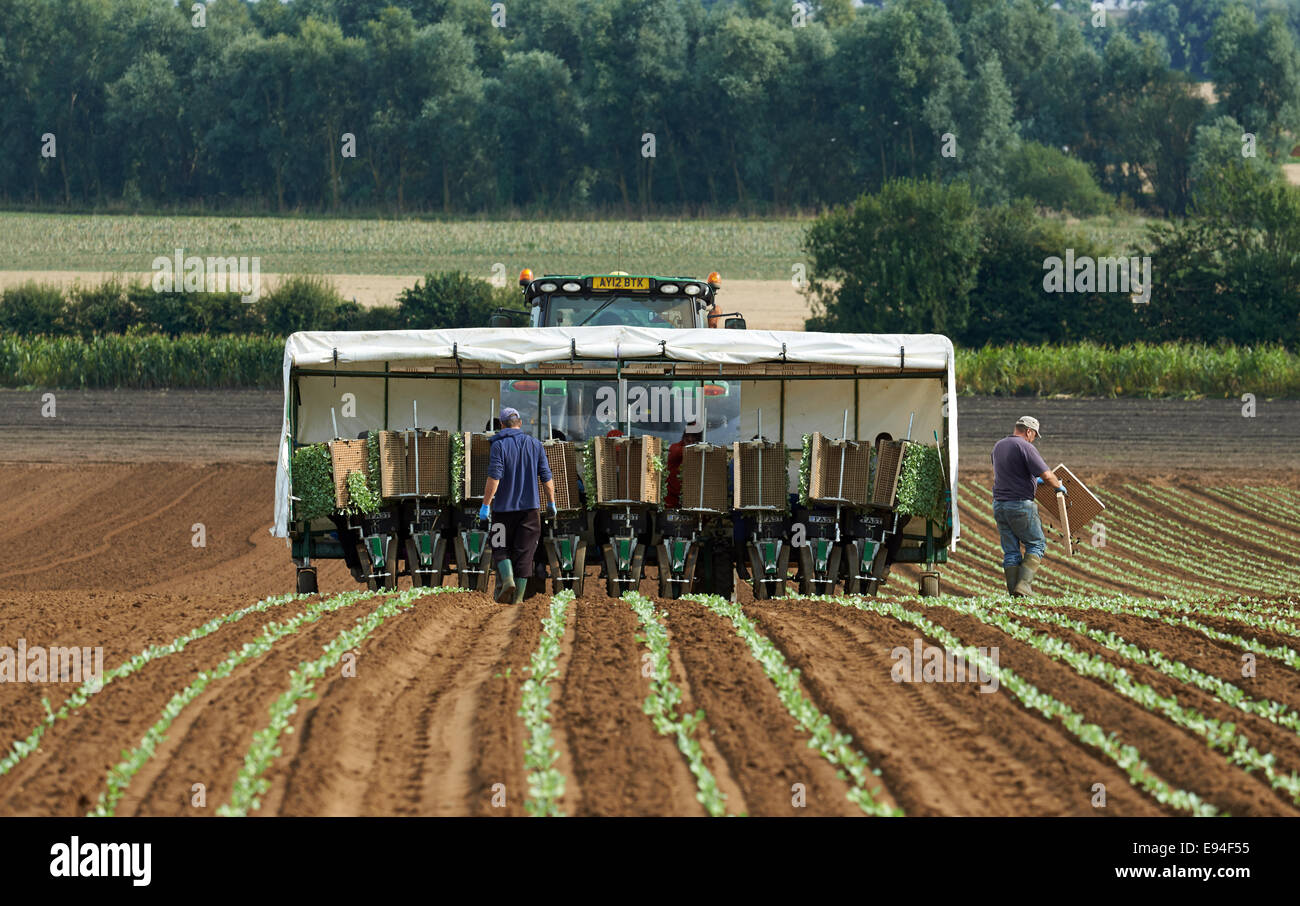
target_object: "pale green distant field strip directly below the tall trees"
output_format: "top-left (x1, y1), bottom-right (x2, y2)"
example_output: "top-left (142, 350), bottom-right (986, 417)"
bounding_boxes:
top-left (0, 213), bottom-right (807, 281)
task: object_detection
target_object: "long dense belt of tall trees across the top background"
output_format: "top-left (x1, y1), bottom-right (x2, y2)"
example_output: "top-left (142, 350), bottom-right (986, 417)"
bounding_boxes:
top-left (0, 0), bottom-right (1300, 213)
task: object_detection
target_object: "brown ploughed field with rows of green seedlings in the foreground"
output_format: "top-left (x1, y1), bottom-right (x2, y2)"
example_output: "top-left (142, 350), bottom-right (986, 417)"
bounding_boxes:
top-left (0, 454), bottom-right (1300, 816)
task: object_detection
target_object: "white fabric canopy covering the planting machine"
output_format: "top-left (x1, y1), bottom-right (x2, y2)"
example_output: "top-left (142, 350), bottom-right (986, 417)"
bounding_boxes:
top-left (272, 326), bottom-right (959, 545)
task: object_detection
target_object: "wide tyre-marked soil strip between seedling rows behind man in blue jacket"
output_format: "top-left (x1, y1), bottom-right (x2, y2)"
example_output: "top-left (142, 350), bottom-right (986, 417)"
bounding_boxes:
top-left (267, 594), bottom-right (533, 815)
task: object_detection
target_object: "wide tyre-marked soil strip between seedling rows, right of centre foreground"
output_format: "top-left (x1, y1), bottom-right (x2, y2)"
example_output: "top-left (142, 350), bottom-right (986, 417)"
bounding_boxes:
top-left (746, 602), bottom-right (1173, 815)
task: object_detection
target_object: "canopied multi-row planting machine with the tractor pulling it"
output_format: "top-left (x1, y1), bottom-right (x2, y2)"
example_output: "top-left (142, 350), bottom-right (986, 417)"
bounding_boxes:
top-left (274, 273), bottom-right (959, 598)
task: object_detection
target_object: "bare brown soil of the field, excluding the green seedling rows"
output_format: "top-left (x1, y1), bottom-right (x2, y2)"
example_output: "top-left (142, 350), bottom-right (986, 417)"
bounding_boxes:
top-left (0, 452), bottom-right (1300, 815)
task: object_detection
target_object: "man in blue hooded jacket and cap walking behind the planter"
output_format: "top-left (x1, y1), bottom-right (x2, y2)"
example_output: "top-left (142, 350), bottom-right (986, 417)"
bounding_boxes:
top-left (478, 406), bottom-right (555, 604)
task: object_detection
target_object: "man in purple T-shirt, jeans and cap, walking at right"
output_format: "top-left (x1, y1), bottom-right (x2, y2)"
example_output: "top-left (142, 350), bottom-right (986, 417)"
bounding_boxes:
top-left (993, 415), bottom-right (1066, 598)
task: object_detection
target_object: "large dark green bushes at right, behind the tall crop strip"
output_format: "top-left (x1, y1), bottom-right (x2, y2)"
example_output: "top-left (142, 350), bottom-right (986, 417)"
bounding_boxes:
top-left (805, 157), bottom-right (1300, 350)
